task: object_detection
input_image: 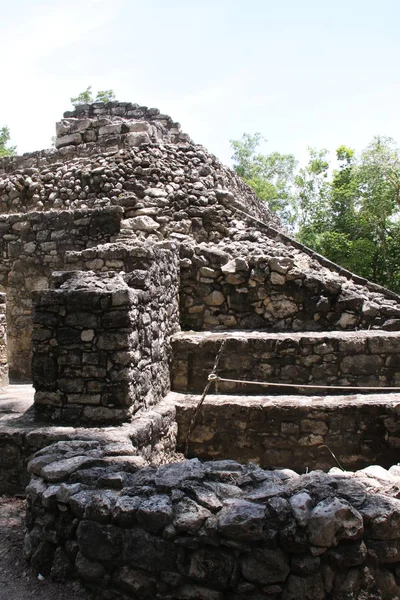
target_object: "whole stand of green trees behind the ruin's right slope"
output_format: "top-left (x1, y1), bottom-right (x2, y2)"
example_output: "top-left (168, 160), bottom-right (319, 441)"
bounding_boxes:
top-left (232, 134), bottom-right (400, 292)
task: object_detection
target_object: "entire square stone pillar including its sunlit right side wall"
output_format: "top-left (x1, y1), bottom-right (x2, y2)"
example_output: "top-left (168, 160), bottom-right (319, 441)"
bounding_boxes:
top-left (32, 247), bottom-right (179, 423)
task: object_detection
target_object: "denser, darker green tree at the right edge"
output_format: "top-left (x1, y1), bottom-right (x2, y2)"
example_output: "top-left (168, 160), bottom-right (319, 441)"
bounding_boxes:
top-left (296, 137), bottom-right (400, 291)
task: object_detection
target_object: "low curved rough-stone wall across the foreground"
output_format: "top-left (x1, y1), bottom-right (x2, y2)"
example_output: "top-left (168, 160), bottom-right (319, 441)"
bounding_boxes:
top-left (24, 442), bottom-right (400, 600)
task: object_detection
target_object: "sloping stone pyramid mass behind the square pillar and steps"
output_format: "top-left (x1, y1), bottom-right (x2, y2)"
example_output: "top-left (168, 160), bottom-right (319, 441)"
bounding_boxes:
top-left (0, 103), bottom-right (400, 378)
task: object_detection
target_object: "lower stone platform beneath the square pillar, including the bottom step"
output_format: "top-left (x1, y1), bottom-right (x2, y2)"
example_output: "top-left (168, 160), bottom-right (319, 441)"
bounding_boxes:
top-left (0, 385), bottom-right (400, 493)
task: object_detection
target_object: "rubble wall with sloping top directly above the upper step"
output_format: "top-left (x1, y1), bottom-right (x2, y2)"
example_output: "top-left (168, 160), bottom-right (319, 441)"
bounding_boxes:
top-left (181, 240), bottom-right (400, 331)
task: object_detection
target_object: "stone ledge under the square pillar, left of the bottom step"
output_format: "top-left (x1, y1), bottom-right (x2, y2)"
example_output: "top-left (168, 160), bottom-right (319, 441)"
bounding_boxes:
top-left (0, 385), bottom-right (176, 494)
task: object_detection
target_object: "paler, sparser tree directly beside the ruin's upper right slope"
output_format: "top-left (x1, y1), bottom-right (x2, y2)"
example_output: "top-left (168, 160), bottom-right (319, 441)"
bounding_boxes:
top-left (231, 133), bottom-right (297, 226)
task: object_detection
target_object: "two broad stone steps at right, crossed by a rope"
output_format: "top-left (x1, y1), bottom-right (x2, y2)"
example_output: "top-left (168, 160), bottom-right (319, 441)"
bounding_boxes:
top-left (171, 330), bottom-right (400, 472)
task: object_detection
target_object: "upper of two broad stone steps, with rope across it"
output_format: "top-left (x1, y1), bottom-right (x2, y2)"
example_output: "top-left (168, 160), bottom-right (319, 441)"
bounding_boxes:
top-left (171, 330), bottom-right (400, 394)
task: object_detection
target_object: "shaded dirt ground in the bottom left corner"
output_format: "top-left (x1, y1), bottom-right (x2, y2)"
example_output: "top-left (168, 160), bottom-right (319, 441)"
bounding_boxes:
top-left (0, 496), bottom-right (93, 600)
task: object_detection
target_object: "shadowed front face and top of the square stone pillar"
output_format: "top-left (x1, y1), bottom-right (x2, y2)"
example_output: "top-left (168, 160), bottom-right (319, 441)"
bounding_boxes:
top-left (32, 271), bottom-right (141, 425)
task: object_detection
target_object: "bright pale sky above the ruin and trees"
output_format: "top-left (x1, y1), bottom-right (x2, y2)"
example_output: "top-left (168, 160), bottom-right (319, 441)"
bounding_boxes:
top-left (0, 0), bottom-right (400, 163)
